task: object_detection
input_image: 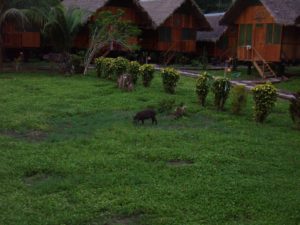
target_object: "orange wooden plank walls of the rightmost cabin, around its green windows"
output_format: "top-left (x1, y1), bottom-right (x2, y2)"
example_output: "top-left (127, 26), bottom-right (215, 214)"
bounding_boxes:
top-left (236, 5), bottom-right (300, 62)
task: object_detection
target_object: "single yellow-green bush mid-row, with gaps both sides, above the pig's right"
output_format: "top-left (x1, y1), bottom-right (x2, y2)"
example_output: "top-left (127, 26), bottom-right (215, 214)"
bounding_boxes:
top-left (161, 68), bottom-right (180, 94)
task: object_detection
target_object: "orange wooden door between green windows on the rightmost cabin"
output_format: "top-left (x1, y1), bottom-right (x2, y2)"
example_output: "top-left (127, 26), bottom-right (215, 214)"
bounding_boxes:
top-left (253, 24), bottom-right (266, 60)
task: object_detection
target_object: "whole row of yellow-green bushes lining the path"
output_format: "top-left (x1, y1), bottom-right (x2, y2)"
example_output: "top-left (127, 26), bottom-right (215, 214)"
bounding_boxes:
top-left (95, 57), bottom-right (300, 127)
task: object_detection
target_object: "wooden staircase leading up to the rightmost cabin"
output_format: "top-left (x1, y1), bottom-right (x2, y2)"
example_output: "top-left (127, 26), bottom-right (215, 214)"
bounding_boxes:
top-left (252, 48), bottom-right (277, 79)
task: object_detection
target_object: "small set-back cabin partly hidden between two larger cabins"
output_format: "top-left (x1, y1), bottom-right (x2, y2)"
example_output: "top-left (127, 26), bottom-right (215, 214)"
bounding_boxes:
top-left (197, 13), bottom-right (238, 61)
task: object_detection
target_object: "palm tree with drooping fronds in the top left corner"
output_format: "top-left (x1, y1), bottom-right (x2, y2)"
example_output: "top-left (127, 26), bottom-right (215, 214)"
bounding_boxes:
top-left (0, 0), bottom-right (60, 70)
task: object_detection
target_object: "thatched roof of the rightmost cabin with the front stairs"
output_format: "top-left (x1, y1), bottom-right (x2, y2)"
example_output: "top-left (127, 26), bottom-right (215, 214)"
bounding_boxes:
top-left (220, 0), bottom-right (300, 25)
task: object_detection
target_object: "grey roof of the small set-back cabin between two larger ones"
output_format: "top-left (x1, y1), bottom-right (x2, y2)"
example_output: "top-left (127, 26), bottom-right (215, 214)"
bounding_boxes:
top-left (197, 13), bottom-right (227, 42)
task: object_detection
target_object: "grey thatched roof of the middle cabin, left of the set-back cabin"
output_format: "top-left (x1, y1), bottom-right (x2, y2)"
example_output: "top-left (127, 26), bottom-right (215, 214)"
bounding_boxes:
top-left (139, 0), bottom-right (211, 30)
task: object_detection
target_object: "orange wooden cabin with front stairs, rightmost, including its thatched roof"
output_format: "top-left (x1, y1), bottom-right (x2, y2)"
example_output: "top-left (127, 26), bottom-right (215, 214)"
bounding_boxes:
top-left (220, 0), bottom-right (300, 78)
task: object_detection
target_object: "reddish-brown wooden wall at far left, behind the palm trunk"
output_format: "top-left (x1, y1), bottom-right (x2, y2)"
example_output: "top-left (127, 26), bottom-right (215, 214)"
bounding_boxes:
top-left (3, 24), bottom-right (41, 48)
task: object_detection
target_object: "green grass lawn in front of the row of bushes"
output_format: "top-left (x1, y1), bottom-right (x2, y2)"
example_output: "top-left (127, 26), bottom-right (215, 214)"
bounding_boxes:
top-left (0, 71), bottom-right (300, 225)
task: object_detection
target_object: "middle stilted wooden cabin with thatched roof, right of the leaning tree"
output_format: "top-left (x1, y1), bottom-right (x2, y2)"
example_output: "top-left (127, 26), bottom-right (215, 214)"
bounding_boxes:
top-left (140, 0), bottom-right (211, 61)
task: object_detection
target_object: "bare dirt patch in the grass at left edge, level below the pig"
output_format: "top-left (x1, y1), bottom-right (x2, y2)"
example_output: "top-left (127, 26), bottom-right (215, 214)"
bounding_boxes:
top-left (0, 130), bottom-right (48, 142)
